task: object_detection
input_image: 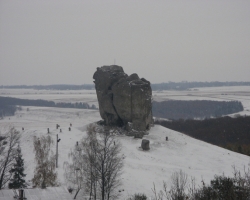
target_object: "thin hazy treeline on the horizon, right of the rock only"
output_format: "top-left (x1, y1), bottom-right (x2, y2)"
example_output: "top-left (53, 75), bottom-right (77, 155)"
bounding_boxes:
top-left (151, 81), bottom-right (250, 90)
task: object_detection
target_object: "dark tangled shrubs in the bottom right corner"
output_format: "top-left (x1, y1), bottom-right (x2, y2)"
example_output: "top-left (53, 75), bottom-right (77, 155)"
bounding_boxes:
top-left (152, 167), bottom-right (250, 200)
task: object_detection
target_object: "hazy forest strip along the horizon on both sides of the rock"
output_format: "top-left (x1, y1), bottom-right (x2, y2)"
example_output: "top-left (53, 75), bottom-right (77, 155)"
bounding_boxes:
top-left (0, 81), bottom-right (250, 91)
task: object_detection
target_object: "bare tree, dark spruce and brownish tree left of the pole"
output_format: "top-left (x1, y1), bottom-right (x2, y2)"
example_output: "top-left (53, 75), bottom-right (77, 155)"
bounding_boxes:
top-left (0, 127), bottom-right (57, 189)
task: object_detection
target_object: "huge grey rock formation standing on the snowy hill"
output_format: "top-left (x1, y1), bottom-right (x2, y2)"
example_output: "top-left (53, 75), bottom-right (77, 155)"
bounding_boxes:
top-left (93, 65), bottom-right (152, 131)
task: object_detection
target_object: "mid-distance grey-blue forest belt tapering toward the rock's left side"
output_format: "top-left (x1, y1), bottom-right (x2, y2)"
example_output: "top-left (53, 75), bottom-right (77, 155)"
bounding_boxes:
top-left (0, 97), bottom-right (96, 117)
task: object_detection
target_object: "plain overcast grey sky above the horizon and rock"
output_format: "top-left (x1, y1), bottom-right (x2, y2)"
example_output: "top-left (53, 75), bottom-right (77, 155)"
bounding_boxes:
top-left (0, 0), bottom-right (250, 85)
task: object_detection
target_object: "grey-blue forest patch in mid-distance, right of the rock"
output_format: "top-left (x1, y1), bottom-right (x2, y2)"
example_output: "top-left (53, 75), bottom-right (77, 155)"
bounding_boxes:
top-left (152, 100), bottom-right (244, 119)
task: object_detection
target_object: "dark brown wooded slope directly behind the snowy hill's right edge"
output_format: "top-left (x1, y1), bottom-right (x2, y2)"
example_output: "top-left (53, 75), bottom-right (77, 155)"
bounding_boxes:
top-left (155, 116), bottom-right (250, 156)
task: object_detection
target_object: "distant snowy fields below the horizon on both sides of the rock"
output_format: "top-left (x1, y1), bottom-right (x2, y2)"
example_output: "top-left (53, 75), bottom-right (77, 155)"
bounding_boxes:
top-left (0, 86), bottom-right (250, 115)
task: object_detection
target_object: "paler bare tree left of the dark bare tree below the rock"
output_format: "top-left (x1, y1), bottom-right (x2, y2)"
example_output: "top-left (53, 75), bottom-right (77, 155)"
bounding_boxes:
top-left (64, 125), bottom-right (97, 199)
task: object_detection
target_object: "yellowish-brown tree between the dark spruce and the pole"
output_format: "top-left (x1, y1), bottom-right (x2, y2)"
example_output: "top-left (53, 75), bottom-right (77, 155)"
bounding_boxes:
top-left (32, 135), bottom-right (58, 188)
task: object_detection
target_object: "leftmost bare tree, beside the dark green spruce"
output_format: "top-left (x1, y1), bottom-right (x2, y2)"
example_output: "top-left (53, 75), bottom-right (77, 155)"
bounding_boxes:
top-left (0, 127), bottom-right (20, 189)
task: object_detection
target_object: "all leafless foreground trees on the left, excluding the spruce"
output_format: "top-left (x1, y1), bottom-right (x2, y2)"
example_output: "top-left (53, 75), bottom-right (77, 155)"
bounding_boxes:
top-left (0, 125), bottom-right (123, 195)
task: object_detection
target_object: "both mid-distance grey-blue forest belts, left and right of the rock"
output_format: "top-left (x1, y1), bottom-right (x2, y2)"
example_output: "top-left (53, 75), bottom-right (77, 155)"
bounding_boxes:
top-left (0, 97), bottom-right (243, 119)
